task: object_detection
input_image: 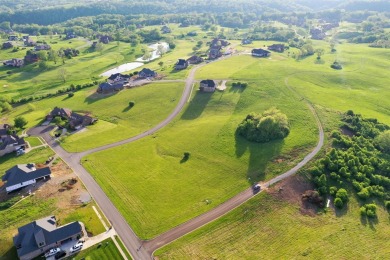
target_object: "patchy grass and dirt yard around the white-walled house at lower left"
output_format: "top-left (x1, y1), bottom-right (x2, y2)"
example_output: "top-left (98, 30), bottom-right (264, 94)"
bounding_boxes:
top-left (0, 148), bottom-right (104, 259)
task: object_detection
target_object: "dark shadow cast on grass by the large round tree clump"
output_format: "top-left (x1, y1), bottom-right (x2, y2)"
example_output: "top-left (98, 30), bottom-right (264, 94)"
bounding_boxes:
top-left (235, 132), bottom-right (284, 184)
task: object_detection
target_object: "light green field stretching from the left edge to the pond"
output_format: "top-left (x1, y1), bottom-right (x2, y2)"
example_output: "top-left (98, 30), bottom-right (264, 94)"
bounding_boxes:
top-left (0, 36), bottom-right (141, 99)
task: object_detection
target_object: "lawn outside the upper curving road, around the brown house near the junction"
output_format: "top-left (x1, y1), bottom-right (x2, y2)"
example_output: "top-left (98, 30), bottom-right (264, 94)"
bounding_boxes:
top-left (4, 82), bottom-right (184, 152)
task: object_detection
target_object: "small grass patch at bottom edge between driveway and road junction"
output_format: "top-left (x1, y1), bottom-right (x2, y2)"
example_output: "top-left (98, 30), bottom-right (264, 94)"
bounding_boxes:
top-left (66, 238), bottom-right (123, 260)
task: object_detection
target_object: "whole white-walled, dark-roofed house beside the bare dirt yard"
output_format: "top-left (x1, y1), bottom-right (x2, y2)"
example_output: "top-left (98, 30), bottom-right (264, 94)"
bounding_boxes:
top-left (2, 163), bottom-right (51, 193)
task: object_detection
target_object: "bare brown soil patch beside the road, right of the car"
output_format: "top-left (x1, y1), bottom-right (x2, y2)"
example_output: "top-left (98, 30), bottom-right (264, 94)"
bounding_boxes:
top-left (267, 175), bottom-right (318, 217)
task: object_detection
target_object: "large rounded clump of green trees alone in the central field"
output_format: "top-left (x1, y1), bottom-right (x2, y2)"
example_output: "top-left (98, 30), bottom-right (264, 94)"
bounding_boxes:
top-left (237, 107), bottom-right (290, 143)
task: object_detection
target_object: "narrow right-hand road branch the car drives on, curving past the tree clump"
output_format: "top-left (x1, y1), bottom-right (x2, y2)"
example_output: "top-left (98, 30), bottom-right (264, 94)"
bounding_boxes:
top-left (145, 94), bottom-right (324, 254)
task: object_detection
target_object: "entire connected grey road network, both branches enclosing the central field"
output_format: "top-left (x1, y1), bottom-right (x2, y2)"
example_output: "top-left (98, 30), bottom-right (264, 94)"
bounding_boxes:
top-left (28, 53), bottom-right (324, 260)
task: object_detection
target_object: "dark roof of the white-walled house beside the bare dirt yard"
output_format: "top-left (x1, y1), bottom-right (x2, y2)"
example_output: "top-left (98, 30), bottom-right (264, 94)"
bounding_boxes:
top-left (2, 164), bottom-right (51, 187)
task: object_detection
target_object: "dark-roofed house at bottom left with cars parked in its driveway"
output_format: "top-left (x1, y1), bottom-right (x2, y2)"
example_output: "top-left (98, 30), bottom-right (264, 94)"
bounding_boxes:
top-left (13, 216), bottom-right (83, 260)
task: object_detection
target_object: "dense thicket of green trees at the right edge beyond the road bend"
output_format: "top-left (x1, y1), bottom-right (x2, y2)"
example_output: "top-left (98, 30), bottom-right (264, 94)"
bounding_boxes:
top-left (310, 111), bottom-right (390, 216)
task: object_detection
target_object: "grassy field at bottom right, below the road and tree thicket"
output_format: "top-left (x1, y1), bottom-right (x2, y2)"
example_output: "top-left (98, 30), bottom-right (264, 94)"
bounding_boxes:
top-left (155, 191), bottom-right (390, 259)
